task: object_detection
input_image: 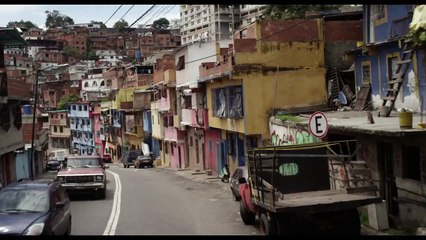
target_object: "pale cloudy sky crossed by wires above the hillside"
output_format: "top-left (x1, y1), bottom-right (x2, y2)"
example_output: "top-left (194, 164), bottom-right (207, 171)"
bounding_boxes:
top-left (0, 4), bottom-right (180, 28)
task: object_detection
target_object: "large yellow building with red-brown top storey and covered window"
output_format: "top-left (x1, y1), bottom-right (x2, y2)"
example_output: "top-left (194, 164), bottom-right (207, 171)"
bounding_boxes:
top-left (200, 19), bottom-right (327, 173)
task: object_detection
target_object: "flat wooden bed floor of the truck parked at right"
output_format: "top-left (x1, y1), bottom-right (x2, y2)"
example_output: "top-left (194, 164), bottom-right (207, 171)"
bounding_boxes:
top-left (256, 190), bottom-right (382, 213)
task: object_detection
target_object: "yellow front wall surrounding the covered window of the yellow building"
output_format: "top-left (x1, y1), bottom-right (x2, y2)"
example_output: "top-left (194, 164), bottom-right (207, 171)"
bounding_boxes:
top-left (206, 78), bottom-right (244, 133)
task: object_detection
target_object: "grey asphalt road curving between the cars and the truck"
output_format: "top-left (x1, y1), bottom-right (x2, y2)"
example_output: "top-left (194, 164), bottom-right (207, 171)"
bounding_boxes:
top-left (71, 165), bottom-right (259, 235)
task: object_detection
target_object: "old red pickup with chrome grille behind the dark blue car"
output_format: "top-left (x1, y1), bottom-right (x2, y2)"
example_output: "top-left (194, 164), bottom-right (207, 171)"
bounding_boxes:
top-left (56, 155), bottom-right (109, 199)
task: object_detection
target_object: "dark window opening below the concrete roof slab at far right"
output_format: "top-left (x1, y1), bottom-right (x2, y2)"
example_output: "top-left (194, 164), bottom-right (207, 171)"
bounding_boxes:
top-left (402, 146), bottom-right (422, 181)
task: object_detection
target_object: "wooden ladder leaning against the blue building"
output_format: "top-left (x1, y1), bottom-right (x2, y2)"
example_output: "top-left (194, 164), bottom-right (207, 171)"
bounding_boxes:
top-left (379, 38), bottom-right (414, 117)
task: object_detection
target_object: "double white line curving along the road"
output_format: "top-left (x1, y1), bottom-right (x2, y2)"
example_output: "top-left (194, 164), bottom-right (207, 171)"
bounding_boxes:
top-left (103, 170), bottom-right (121, 235)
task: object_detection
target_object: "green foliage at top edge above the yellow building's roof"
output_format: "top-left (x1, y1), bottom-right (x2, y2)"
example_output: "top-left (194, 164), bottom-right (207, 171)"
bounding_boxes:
top-left (263, 4), bottom-right (342, 19)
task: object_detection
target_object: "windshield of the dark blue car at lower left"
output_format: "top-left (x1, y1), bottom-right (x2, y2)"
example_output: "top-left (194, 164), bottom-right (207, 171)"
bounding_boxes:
top-left (0, 189), bottom-right (49, 213)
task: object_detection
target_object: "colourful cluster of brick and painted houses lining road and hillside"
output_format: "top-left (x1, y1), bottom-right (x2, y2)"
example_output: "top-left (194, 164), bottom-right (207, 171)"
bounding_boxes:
top-left (0, 5), bottom-right (426, 232)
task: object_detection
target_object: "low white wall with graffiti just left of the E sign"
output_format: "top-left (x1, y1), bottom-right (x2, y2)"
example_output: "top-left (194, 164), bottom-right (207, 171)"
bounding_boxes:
top-left (269, 124), bottom-right (321, 146)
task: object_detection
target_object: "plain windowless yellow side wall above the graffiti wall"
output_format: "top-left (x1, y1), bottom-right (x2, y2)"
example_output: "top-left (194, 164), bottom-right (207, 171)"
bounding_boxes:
top-left (238, 68), bottom-right (327, 139)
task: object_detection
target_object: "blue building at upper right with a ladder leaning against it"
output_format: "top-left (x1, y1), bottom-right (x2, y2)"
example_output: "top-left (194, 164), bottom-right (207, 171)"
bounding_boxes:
top-left (347, 4), bottom-right (426, 112)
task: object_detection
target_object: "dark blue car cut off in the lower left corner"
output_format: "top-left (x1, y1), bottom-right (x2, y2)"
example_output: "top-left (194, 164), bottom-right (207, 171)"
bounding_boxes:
top-left (0, 179), bottom-right (71, 236)
